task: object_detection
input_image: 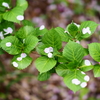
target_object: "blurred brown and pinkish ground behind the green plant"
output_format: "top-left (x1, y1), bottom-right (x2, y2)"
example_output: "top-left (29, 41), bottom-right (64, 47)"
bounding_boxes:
top-left (0, 0), bottom-right (100, 100)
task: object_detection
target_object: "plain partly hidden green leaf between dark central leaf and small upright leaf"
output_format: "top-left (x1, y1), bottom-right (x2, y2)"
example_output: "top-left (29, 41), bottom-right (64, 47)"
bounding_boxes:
top-left (55, 27), bottom-right (69, 42)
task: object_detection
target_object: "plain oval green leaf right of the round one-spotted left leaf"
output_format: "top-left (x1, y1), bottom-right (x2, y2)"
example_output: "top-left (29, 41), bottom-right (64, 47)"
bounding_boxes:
top-left (24, 35), bottom-right (38, 53)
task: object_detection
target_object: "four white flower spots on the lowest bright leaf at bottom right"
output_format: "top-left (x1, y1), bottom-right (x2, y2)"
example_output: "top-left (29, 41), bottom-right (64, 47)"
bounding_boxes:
top-left (72, 72), bottom-right (90, 88)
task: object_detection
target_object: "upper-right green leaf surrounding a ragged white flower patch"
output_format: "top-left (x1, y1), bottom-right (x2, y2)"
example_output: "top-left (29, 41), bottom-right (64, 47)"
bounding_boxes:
top-left (79, 21), bottom-right (98, 39)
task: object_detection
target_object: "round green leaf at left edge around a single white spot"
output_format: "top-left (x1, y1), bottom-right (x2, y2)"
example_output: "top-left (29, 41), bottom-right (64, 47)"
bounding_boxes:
top-left (0, 36), bottom-right (22, 55)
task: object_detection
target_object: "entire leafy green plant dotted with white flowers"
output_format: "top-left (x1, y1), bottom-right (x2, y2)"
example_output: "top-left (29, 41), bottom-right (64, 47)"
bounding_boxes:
top-left (0, 0), bottom-right (100, 92)
